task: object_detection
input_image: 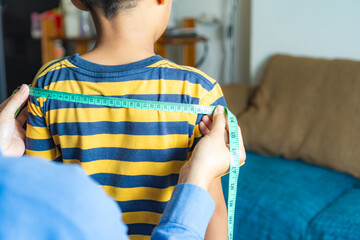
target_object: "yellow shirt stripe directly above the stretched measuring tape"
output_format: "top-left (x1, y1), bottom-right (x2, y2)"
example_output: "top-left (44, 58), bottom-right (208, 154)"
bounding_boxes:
top-left (45, 79), bottom-right (207, 98)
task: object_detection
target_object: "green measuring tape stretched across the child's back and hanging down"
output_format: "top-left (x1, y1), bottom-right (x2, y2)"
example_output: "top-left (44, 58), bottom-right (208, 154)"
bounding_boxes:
top-left (30, 87), bottom-right (240, 240)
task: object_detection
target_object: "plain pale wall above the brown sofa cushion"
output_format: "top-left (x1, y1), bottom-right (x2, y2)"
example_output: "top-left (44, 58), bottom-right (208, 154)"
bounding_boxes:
top-left (250, 0), bottom-right (360, 84)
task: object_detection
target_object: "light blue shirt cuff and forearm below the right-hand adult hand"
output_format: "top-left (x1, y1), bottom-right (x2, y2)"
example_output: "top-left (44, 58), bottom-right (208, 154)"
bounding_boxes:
top-left (151, 184), bottom-right (215, 240)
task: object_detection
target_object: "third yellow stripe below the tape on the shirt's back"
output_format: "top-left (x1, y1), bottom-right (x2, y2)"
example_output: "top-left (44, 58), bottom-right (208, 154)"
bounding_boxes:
top-left (80, 160), bottom-right (185, 176)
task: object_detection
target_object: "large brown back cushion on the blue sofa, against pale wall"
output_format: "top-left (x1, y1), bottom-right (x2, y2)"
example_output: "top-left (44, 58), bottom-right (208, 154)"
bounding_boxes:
top-left (239, 55), bottom-right (360, 178)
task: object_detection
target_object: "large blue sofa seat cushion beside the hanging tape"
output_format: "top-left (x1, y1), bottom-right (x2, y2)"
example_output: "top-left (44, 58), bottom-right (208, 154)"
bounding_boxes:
top-left (222, 153), bottom-right (359, 240)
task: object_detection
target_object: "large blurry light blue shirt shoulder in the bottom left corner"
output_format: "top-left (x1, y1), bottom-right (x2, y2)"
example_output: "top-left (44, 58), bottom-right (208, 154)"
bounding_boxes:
top-left (0, 152), bottom-right (129, 240)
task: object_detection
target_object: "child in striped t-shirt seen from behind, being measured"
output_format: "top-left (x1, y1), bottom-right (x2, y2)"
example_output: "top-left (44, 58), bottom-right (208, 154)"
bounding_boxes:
top-left (26, 0), bottom-right (227, 240)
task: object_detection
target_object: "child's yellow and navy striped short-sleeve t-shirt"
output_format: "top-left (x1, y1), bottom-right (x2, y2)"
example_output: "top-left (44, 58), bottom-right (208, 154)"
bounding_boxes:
top-left (26, 55), bottom-right (226, 239)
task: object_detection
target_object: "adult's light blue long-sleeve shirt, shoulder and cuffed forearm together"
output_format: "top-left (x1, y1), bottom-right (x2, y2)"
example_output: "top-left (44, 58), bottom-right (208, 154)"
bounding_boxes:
top-left (0, 153), bottom-right (215, 240)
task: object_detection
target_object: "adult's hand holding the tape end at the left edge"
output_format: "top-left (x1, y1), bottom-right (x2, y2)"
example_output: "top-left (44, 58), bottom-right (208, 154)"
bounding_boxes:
top-left (0, 84), bottom-right (29, 157)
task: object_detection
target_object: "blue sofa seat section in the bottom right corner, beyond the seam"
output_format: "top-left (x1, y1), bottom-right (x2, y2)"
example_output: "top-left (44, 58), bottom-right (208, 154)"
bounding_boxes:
top-left (307, 189), bottom-right (360, 240)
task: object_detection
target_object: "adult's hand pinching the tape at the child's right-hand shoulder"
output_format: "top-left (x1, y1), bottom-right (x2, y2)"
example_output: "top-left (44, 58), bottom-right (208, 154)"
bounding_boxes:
top-left (179, 106), bottom-right (246, 190)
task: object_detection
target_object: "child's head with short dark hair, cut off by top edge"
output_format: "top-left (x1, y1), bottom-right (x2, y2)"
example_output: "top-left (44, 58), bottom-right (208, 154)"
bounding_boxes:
top-left (71, 0), bottom-right (172, 40)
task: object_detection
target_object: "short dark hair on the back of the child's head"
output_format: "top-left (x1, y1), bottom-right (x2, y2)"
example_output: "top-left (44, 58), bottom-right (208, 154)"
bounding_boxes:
top-left (80, 0), bottom-right (139, 18)
